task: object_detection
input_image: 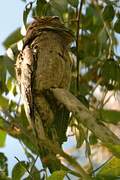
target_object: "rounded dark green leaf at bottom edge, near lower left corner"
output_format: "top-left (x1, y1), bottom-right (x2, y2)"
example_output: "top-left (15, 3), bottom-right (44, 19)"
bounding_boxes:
top-left (12, 161), bottom-right (28, 180)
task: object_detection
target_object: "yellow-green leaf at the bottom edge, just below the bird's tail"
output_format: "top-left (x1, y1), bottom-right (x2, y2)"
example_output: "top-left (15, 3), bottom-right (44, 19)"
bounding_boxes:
top-left (47, 170), bottom-right (67, 180)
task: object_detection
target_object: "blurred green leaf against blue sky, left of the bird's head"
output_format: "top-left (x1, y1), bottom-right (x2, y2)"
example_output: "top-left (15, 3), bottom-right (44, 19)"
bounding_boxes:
top-left (3, 28), bottom-right (23, 48)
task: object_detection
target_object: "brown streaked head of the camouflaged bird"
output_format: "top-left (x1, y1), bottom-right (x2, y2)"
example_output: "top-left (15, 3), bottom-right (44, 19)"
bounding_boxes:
top-left (25, 16), bottom-right (74, 47)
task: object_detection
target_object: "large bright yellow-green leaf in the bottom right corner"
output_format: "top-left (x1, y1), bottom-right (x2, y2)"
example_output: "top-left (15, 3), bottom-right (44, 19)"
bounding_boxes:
top-left (97, 157), bottom-right (120, 178)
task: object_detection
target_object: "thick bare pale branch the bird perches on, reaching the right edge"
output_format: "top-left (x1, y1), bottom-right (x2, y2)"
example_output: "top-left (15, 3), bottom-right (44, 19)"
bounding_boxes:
top-left (51, 88), bottom-right (120, 146)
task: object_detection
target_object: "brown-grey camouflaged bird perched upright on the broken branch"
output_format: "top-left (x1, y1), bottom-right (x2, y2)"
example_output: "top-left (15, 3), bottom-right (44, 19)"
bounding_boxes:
top-left (16, 16), bottom-right (73, 147)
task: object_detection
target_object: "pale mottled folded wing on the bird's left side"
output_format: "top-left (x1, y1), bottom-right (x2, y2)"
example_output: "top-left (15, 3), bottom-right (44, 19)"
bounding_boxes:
top-left (16, 46), bottom-right (34, 123)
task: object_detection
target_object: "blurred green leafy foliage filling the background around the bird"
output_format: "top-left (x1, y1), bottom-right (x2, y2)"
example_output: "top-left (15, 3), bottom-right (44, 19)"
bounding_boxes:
top-left (0, 0), bottom-right (120, 180)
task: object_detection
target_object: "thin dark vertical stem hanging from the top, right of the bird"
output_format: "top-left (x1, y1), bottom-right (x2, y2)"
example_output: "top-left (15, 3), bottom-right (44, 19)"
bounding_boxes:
top-left (76, 0), bottom-right (83, 92)
